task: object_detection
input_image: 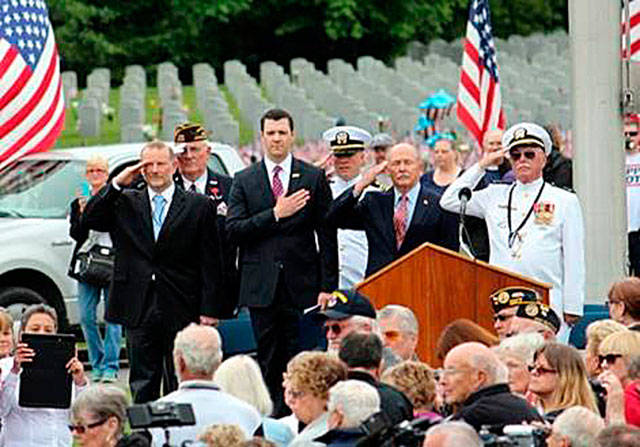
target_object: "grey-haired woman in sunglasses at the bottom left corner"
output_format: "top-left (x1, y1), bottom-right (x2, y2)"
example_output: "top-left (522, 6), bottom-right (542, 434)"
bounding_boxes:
top-left (69, 385), bottom-right (149, 447)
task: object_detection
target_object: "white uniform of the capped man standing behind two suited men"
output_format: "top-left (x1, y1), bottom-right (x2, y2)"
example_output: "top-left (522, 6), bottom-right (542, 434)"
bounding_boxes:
top-left (330, 175), bottom-right (369, 289)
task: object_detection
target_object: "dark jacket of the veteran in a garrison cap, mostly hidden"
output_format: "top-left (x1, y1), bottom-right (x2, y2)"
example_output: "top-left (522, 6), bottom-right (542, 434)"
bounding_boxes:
top-left (173, 168), bottom-right (240, 318)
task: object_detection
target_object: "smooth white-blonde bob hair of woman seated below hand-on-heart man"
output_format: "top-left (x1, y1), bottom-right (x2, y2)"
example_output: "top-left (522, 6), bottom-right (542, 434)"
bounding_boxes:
top-left (213, 355), bottom-right (273, 416)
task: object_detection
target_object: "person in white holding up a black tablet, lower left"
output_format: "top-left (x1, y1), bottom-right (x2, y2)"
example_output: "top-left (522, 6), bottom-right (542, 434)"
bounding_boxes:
top-left (0, 304), bottom-right (89, 447)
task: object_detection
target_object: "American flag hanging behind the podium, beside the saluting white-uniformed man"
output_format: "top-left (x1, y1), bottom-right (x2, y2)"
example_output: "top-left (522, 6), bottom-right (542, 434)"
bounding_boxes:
top-left (456, 0), bottom-right (506, 145)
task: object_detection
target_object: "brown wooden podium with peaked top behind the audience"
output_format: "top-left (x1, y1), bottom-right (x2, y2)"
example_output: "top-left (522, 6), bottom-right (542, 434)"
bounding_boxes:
top-left (356, 243), bottom-right (551, 367)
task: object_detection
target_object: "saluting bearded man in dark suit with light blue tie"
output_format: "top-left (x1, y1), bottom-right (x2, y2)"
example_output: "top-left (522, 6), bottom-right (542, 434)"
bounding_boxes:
top-left (84, 141), bottom-right (221, 403)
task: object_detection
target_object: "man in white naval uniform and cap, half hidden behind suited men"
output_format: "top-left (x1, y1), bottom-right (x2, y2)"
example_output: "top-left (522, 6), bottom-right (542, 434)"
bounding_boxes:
top-left (322, 126), bottom-right (371, 289)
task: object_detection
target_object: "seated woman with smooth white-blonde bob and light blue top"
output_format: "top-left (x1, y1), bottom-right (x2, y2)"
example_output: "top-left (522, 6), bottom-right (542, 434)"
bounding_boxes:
top-left (213, 355), bottom-right (297, 446)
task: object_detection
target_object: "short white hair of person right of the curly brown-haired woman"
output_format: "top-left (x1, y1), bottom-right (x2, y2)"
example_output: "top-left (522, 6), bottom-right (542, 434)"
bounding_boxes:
top-left (327, 380), bottom-right (380, 428)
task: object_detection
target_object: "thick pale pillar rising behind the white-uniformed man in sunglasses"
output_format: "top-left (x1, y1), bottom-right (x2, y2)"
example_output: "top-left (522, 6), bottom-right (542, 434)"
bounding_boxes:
top-left (569, 0), bottom-right (627, 304)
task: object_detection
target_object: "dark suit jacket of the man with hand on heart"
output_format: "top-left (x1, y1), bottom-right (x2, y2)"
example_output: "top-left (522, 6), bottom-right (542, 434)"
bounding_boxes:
top-left (227, 158), bottom-right (338, 308)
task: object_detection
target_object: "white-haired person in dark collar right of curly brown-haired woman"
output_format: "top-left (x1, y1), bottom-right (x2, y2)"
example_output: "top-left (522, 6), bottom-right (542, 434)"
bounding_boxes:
top-left (316, 380), bottom-right (380, 447)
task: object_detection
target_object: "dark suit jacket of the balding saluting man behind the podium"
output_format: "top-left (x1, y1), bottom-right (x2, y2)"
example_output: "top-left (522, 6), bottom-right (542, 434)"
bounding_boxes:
top-left (327, 186), bottom-right (458, 276)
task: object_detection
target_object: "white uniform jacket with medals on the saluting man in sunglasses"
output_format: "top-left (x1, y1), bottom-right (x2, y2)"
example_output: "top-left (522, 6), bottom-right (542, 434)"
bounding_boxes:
top-left (440, 164), bottom-right (585, 340)
